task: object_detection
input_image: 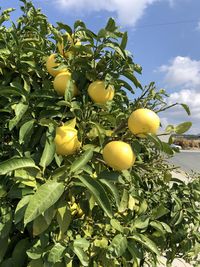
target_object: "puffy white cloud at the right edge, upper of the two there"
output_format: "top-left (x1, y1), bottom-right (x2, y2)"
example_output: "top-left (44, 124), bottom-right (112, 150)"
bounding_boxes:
top-left (159, 56), bottom-right (200, 87)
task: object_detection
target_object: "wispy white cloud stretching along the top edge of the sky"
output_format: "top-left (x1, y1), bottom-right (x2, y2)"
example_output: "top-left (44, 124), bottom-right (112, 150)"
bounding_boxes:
top-left (55, 0), bottom-right (159, 26)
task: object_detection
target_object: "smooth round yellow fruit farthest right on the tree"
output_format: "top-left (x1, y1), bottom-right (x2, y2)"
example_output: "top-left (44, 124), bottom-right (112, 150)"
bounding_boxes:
top-left (128, 108), bottom-right (160, 137)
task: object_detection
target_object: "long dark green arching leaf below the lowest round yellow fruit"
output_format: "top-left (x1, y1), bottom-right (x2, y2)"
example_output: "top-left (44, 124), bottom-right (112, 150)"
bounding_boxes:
top-left (77, 175), bottom-right (112, 218)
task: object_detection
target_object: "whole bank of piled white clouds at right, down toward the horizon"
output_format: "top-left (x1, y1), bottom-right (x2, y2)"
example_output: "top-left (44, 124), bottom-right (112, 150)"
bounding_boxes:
top-left (159, 56), bottom-right (200, 133)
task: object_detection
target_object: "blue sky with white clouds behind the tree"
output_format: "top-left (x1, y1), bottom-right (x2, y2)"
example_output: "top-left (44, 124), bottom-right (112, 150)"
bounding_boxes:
top-left (0, 0), bottom-right (200, 134)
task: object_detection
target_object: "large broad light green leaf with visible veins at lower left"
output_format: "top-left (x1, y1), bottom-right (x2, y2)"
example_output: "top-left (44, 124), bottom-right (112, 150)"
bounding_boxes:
top-left (24, 180), bottom-right (64, 225)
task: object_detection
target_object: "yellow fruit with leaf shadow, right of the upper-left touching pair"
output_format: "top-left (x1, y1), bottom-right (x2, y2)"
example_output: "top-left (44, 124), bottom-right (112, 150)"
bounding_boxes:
top-left (88, 80), bottom-right (115, 104)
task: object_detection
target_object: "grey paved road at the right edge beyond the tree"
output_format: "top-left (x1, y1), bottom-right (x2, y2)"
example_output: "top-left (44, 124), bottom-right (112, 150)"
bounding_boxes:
top-left (170, 150), bottom-right (200, 172)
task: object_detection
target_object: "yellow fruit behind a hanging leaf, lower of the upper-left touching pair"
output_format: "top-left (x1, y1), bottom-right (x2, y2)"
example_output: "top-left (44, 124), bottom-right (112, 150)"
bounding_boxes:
top-left (53, 71), bottom-right (78, 96)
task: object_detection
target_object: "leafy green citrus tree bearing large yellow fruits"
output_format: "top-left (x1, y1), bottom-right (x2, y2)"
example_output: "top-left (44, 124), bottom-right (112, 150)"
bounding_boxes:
top-left (0, 0), bottom-right (200, 267)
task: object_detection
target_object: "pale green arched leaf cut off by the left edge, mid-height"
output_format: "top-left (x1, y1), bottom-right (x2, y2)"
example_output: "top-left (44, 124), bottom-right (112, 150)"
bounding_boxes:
top-left (0, 158), bottom-right (38, 175)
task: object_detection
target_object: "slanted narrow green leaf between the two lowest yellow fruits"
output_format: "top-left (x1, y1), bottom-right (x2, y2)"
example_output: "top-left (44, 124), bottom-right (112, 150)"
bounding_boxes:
top-left (70, 147), bottom-right (94, 173)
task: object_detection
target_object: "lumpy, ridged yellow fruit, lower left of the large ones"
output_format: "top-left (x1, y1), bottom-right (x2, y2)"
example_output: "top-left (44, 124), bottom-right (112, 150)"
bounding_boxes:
top-left (54, 125), bottom-right (81, 155)
